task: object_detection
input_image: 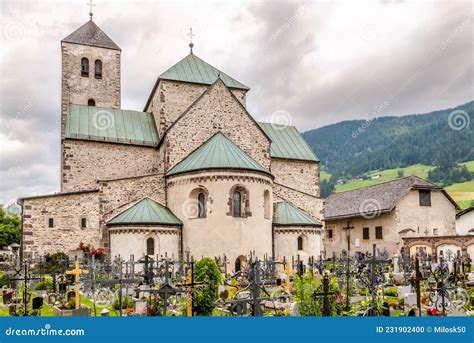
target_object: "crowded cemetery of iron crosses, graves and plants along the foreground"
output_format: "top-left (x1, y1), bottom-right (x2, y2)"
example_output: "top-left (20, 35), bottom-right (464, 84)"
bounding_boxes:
top-left (0, 244), bottom-right (474, 317)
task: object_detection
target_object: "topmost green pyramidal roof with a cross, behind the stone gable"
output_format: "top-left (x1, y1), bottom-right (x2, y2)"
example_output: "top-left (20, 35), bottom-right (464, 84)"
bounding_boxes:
top-left (159, 54), bottom-right (250, 90)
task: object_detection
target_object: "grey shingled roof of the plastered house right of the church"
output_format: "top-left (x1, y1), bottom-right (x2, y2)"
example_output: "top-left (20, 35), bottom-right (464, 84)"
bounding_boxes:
top-left (325, 176), bottom-right (439, 220)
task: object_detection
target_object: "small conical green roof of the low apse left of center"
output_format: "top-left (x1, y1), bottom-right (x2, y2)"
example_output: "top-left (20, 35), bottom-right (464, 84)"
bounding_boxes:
top-left (107, 198), bottom-right (183, 225)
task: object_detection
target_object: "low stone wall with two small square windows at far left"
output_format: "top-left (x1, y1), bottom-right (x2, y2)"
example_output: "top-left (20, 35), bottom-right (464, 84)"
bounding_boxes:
top-left (22, 191), bottom-right (100, 256)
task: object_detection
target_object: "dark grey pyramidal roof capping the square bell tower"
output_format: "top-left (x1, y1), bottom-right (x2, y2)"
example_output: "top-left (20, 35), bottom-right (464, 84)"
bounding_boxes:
top-left (62, 20), bottom-right (120, 50)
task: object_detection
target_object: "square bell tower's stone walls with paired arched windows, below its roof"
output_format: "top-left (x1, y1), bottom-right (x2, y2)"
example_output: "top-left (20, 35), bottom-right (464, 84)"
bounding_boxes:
top-left (61, 42), bottom-right (120, 138)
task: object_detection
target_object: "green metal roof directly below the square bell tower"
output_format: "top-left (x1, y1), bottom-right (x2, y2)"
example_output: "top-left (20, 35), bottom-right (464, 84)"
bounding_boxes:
top-left (66, 105), bottom-right (158, 146)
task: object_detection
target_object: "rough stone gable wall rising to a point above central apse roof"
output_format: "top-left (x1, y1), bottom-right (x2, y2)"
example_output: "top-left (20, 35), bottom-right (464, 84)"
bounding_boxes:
top-left (165, 80), bottom-right (270, 171)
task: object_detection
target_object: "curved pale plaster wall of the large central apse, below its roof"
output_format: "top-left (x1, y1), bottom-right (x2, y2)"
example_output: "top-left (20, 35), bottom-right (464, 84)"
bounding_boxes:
top-left (167, 171), bottom-right (273, 266)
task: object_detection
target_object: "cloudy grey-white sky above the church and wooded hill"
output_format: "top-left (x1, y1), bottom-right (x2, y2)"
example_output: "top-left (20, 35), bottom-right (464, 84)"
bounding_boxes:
top-left (0, 0), bottom-right (474, 204)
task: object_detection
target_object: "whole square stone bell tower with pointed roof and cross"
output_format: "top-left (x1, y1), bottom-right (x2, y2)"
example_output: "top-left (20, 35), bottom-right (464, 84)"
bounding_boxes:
top-left (61, 10), bottom-right (121, 141)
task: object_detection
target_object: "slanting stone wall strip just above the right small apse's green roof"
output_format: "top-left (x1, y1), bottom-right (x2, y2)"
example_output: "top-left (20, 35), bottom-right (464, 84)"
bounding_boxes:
top-left (273, 183), bottom-right (324, 224)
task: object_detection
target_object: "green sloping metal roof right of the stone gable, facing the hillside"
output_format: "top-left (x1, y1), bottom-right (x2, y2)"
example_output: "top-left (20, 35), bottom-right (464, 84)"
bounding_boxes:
top-left (258, 122), bottom-right (319, 161)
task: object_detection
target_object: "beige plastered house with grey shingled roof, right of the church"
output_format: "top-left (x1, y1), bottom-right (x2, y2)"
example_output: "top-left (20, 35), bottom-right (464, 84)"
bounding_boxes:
top-left (323, 176), bottom-right (458, 254)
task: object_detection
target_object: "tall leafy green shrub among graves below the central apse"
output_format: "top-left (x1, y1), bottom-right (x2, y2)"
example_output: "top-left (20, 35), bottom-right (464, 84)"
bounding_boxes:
top-left (193, 257), bottom-right (222, 316)
